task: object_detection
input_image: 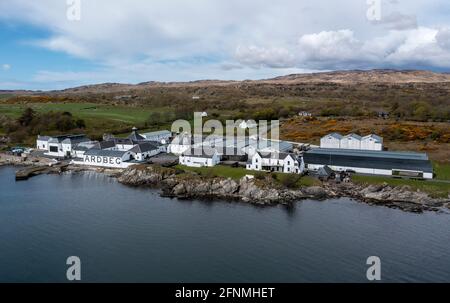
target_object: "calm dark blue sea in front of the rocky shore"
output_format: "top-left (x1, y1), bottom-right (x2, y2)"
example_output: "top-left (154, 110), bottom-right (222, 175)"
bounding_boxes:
top-left (0, 167), bottom-right (450, 282)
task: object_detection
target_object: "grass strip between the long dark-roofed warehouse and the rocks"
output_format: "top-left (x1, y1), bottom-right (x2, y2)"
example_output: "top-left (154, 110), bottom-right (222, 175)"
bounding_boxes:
top-left (352, 175), bottom-right (450, 198)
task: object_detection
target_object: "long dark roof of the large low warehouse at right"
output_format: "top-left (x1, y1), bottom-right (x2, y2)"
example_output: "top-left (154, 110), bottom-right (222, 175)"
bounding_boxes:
top-left (303, 149), bottom-right (433, 173)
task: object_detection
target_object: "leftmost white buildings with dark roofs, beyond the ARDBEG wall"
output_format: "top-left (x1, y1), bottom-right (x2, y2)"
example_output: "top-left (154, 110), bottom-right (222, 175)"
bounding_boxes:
top-left (36, 135), bottom-right (91, 158)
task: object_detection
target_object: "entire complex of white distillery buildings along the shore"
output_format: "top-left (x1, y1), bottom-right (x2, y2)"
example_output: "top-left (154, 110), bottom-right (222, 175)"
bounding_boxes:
top-left (36, 124), bottom-right (433, 179)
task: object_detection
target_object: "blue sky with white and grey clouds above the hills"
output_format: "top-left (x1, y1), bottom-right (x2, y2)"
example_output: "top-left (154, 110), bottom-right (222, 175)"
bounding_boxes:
top-left (0, 0), bottom-right (450, 90)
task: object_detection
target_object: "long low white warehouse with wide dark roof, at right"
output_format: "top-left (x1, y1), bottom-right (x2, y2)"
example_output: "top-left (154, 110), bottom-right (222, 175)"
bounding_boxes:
top-left (303, 148), bottom-right (434, 179)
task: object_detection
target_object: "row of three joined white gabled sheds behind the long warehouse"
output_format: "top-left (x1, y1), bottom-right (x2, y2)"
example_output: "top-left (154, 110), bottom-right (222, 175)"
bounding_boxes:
top-left (320, 133), bottom-right (383, 151)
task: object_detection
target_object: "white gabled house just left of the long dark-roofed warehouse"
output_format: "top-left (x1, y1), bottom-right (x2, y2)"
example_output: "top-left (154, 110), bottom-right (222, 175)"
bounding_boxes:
top-left (247, 152), bottom-right (305, 174)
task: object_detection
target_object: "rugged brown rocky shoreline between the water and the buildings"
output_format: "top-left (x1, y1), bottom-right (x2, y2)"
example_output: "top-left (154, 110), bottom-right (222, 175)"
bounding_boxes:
top-left (0, 157), bottom-right (450, 213)
